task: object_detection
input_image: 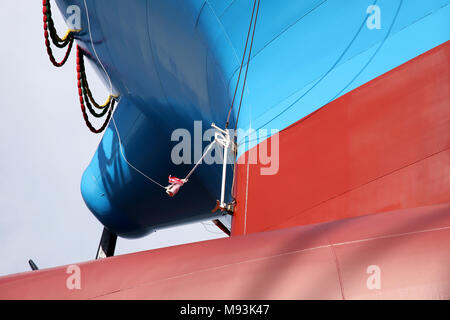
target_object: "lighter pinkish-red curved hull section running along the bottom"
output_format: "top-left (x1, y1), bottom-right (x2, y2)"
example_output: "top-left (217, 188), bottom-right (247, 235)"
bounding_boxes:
top-left (0, 203), bottom-right (450, 299)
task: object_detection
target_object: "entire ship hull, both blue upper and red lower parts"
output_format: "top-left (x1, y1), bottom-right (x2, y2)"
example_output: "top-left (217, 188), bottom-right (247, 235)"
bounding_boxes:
top-left (0, 0), bottom-right (450, 299)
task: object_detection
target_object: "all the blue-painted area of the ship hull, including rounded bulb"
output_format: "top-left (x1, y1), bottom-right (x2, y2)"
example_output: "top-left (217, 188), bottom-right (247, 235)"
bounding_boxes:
top-left (50, 0), bottom-right (450, 237)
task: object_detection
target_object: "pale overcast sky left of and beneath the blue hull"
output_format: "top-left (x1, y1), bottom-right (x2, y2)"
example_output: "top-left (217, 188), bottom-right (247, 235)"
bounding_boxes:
top-left (0, 0), bottom-right (224, 275)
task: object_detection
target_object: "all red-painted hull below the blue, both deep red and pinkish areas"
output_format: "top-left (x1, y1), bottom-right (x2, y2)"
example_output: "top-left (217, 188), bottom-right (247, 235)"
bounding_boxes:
top-left (0, 28), bottom-right (450, 299)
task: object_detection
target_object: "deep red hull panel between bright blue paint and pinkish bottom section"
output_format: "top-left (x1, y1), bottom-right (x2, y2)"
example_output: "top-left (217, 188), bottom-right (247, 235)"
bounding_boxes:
top-left (232, 41), bottom-right (450, 235)
